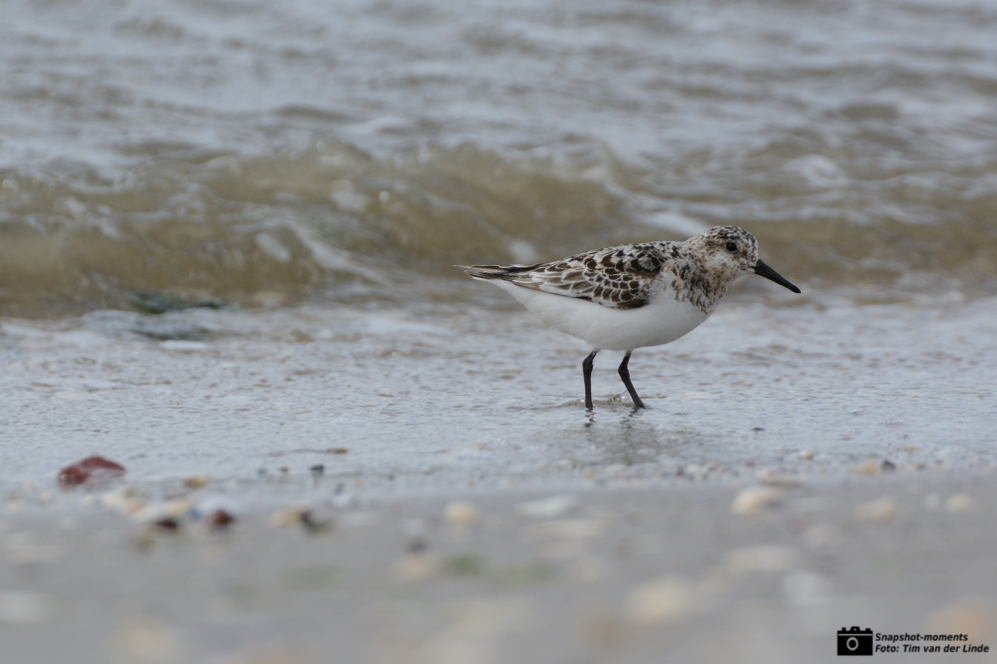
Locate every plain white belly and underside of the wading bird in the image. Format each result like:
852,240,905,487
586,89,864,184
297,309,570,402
489,280,712,350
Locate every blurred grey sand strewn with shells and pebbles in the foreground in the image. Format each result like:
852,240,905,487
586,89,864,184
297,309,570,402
0,471,997,664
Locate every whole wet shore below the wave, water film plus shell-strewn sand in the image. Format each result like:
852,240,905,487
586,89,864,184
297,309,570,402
0,291,997,664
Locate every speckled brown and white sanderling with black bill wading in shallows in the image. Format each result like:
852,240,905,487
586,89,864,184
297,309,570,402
457,226,800,410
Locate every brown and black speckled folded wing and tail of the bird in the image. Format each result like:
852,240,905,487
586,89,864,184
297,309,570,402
462,242,667,309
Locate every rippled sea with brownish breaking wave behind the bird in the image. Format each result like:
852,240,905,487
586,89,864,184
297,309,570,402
0,0,997,316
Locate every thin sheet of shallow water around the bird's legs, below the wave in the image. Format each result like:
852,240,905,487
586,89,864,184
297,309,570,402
0,296,997,488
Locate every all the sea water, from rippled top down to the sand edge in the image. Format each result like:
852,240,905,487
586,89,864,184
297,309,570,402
0,0,997,488
